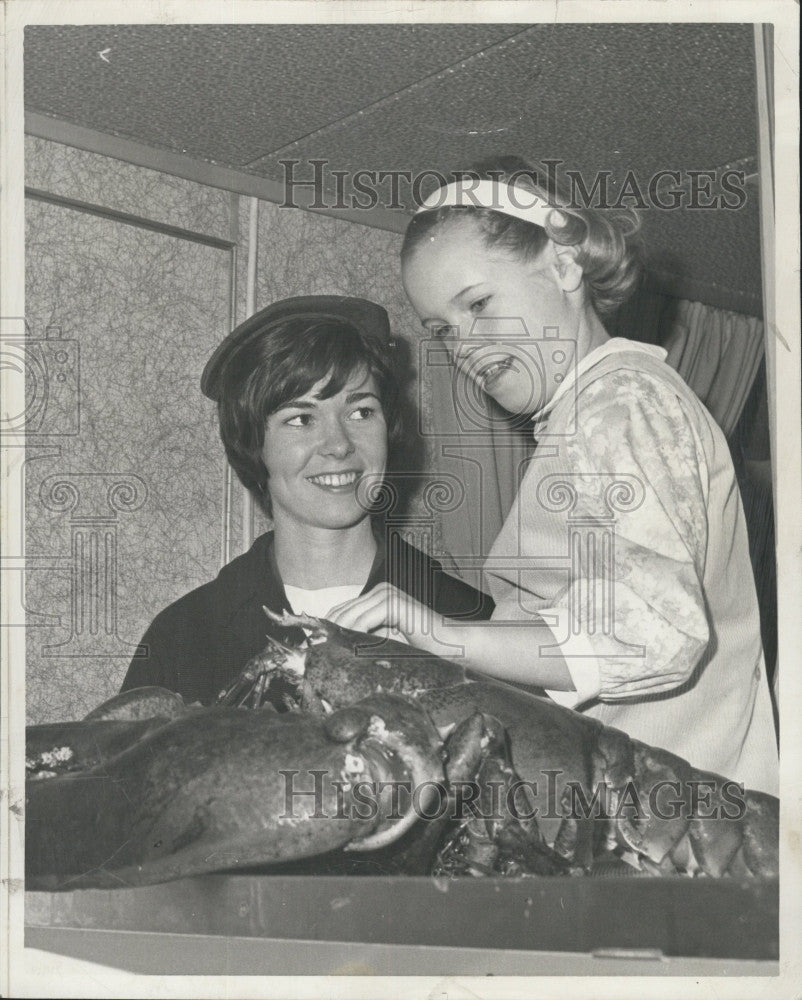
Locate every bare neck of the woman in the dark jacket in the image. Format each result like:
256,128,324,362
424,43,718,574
273,515,376,590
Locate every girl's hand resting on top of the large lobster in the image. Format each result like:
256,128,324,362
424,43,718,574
326,583,441,653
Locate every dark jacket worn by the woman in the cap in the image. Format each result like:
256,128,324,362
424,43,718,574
122,532,493,705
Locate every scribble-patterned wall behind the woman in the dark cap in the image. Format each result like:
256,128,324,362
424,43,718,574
24,138,432,723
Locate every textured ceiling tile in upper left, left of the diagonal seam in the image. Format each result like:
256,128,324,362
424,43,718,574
25,25,521,166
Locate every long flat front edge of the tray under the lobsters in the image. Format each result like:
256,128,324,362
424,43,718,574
26,875,779,974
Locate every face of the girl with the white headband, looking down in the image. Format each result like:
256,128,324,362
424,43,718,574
402,219,584,414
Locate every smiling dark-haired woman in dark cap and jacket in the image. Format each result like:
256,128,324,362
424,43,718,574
123,296,493,704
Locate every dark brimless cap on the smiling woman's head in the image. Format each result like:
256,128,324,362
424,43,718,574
201,295,392,402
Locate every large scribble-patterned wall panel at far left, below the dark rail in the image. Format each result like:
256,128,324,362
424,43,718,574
26,191,229,722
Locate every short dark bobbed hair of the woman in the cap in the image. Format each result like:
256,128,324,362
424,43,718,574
217,317,403,516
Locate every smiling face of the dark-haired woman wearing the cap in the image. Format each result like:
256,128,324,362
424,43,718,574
262,371,387,529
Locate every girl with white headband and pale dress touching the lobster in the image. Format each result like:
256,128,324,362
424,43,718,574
330,158,778,794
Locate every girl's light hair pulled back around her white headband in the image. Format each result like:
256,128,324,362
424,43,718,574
401,156,642,316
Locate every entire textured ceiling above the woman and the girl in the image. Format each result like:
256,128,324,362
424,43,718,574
25,24,760,312
